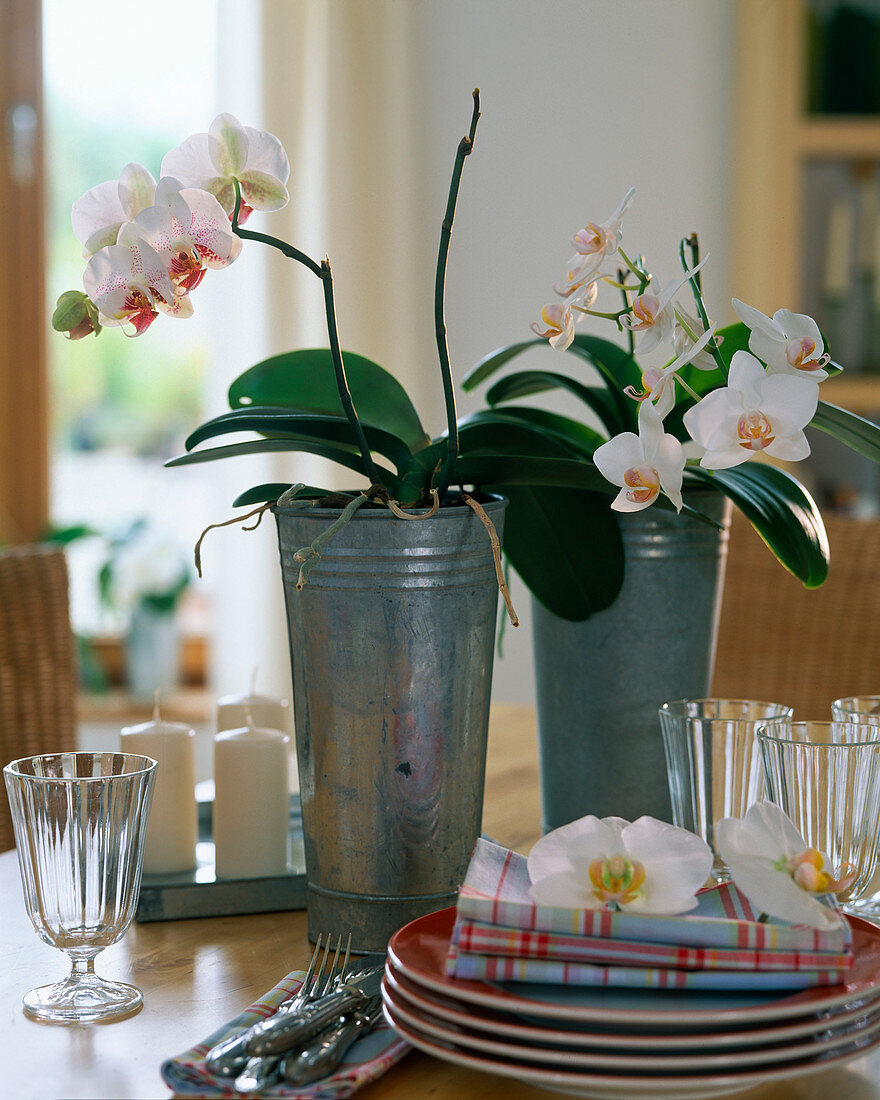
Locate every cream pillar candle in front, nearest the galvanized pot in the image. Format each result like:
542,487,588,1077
213,724,290,879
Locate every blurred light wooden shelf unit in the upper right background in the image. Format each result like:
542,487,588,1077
730,0,880,510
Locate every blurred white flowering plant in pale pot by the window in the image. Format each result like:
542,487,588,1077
98,519,191,702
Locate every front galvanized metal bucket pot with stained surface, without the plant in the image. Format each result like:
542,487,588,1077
275,499,507,952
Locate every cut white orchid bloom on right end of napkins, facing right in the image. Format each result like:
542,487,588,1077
715,801,856,928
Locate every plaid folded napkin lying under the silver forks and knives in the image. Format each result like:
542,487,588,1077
162,970,409,1100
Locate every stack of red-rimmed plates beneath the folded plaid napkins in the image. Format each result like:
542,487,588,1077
383,909,880,1100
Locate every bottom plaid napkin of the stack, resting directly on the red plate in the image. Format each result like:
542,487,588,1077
447,944,845,990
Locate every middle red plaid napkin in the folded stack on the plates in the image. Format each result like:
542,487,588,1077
452,921,853,980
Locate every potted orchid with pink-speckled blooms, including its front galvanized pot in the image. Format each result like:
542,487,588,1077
54,92,624,949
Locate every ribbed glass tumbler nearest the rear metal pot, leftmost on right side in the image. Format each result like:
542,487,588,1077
660,699,792,882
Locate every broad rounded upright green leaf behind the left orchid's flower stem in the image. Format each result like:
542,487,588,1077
229,348,430,451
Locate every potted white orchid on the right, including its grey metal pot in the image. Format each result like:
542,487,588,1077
461,191,880,828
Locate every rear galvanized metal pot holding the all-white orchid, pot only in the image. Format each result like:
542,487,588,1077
532,492,730,832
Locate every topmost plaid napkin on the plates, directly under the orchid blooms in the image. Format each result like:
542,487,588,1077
458,838,851,960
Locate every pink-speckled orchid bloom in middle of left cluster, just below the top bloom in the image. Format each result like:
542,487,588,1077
119,176,242,296
